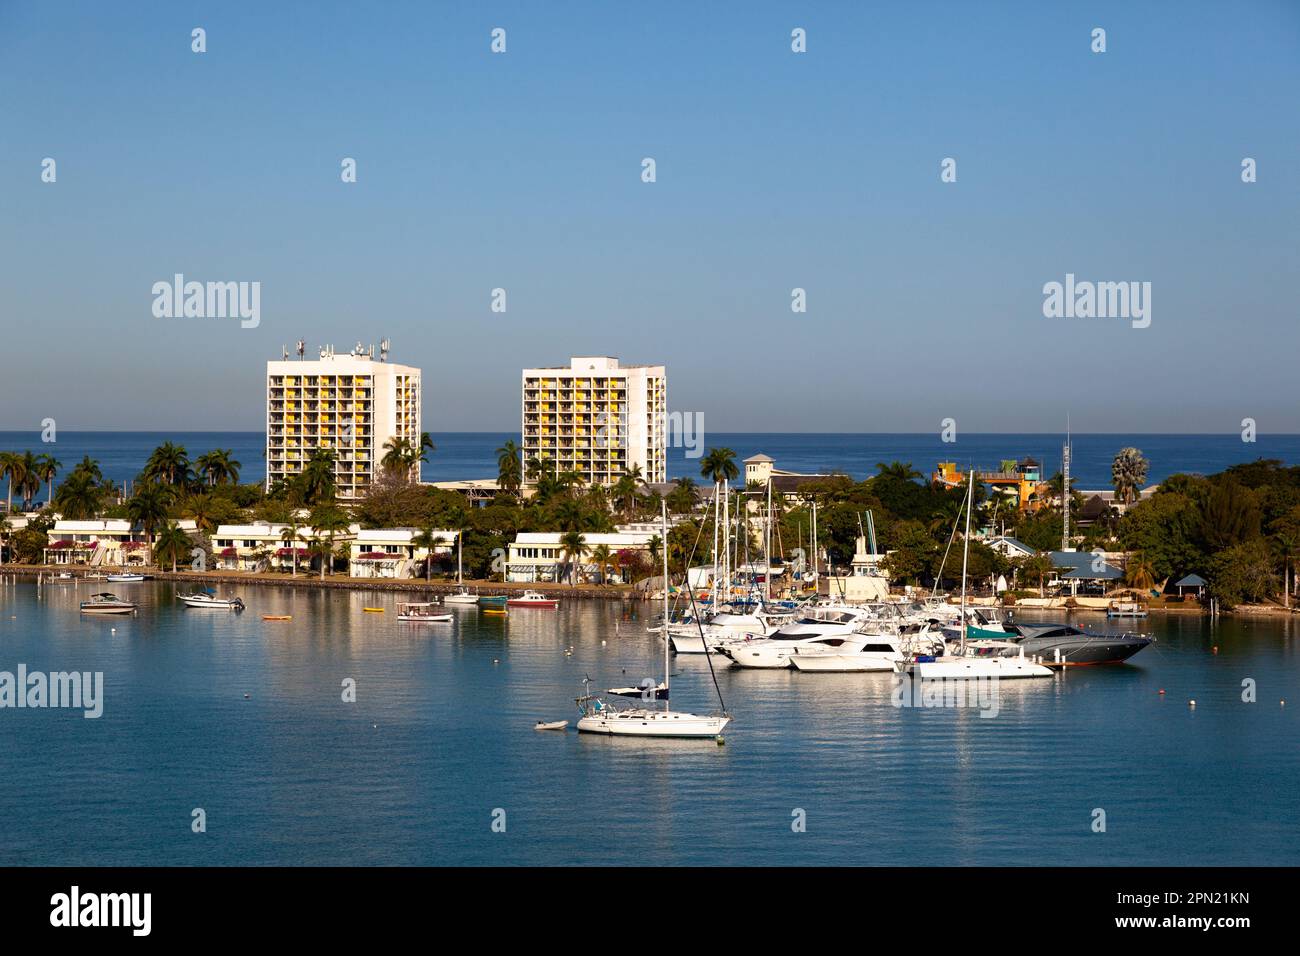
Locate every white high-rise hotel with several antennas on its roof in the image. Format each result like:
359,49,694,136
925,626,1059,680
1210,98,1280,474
267,342,420,499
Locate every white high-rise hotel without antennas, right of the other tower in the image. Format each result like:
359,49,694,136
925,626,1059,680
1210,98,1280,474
523,356,668,485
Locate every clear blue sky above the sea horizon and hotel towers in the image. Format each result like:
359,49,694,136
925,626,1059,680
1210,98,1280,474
0,0,1300,432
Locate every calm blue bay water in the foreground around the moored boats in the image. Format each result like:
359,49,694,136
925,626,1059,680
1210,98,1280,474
0,579,1300,865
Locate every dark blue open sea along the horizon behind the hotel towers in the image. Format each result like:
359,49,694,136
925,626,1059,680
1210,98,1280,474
0,431,1300,490
